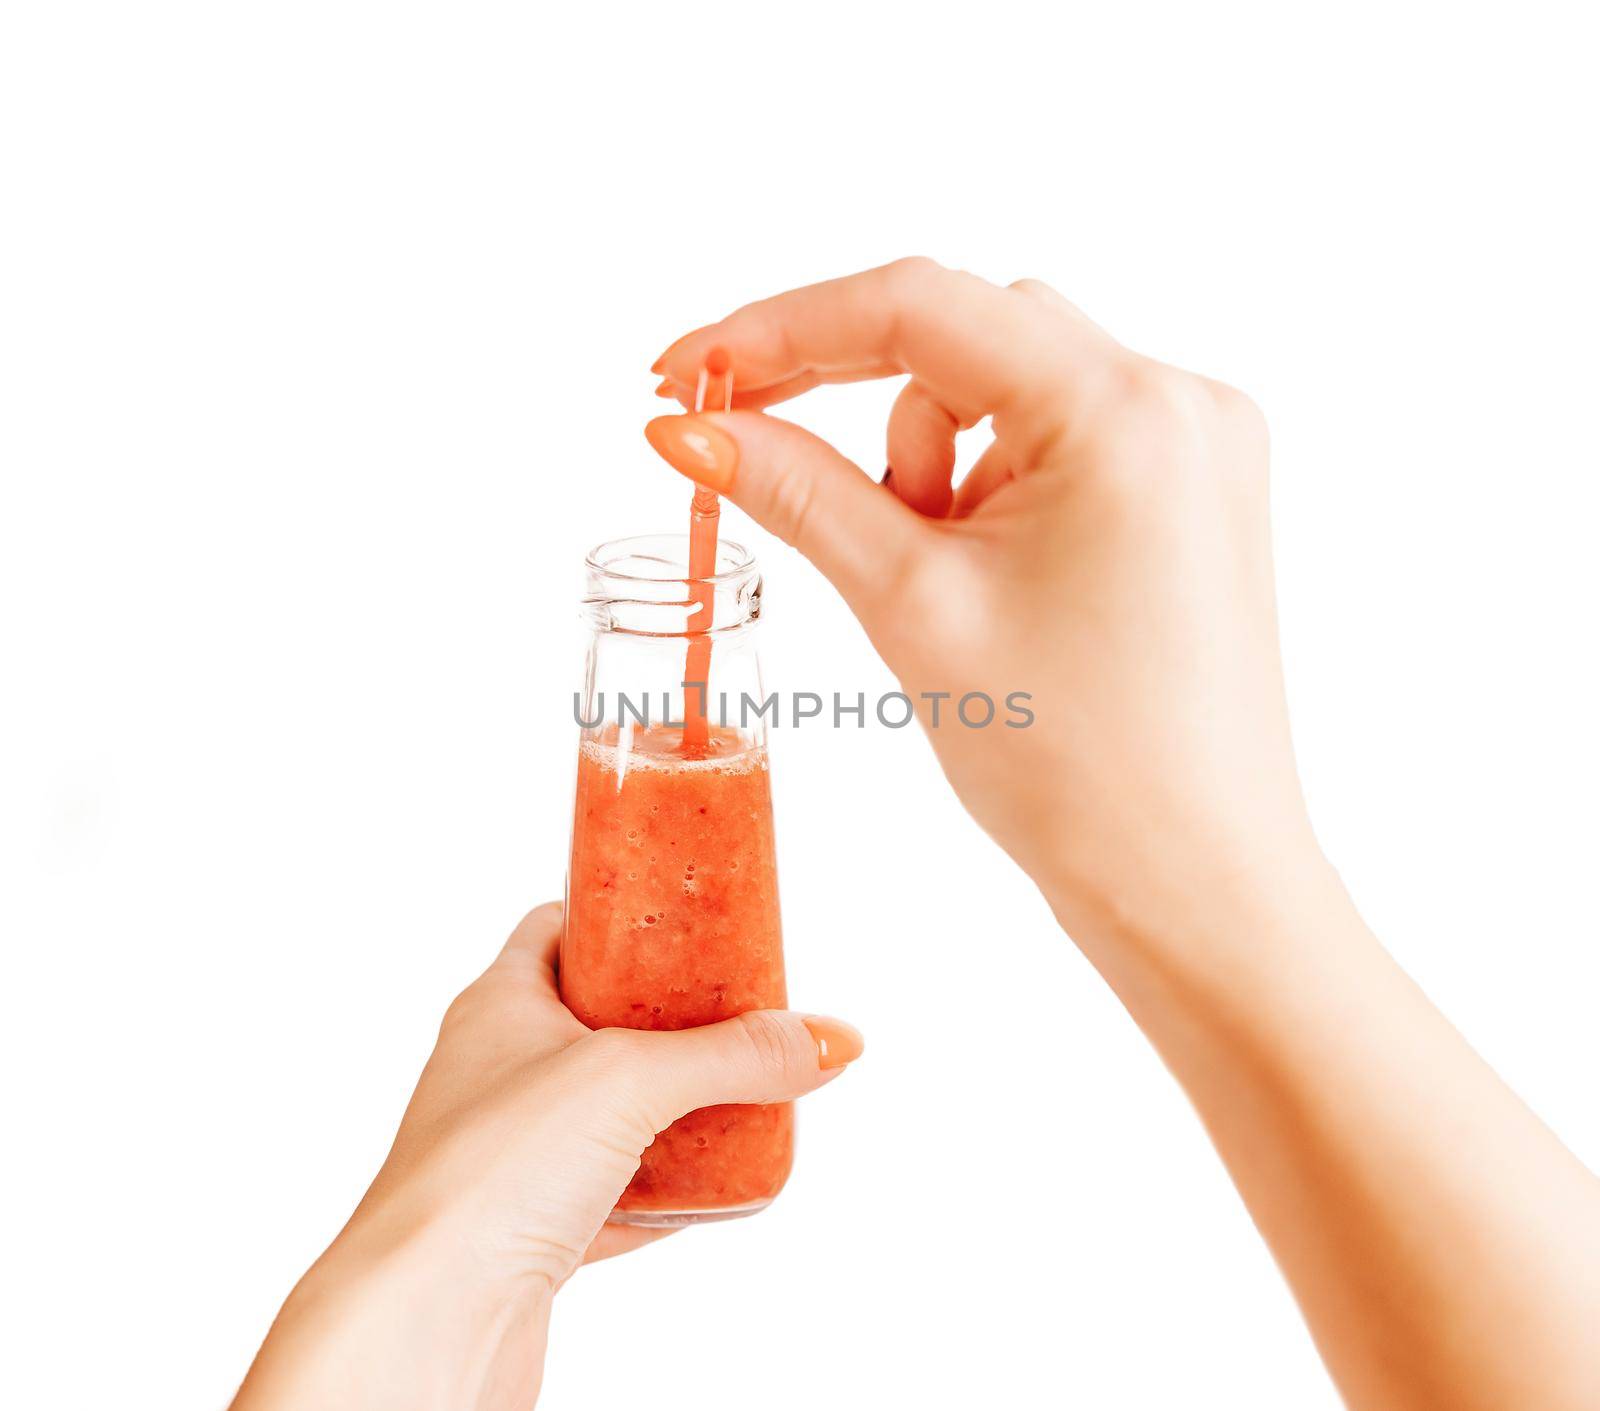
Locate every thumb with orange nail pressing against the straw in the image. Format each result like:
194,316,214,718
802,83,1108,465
645,411,930,627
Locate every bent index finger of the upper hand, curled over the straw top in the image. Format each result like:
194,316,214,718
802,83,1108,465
656,259,1115,426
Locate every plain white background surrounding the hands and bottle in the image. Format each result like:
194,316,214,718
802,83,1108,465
0,0,1600,1411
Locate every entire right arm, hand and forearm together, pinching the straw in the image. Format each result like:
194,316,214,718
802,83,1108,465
648,261,1600,1411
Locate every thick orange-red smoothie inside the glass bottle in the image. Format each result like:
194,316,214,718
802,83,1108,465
562,726,794,1222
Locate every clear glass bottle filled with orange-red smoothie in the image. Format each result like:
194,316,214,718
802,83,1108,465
560,534,794,1225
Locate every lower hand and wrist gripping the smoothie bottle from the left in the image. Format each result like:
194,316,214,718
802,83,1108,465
234,904,861,1411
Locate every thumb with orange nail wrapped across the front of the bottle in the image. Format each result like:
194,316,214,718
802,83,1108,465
617,1009,862,1131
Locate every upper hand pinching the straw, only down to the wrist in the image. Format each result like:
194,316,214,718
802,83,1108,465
648,259,1317,941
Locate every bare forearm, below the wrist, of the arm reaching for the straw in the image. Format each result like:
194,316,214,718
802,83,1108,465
1058,857,1600,1408
